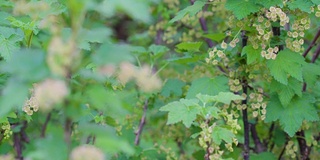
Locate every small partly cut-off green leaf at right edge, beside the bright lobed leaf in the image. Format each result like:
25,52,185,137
302,63,320,87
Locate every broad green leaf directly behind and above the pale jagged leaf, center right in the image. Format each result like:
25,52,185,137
186,76,229,98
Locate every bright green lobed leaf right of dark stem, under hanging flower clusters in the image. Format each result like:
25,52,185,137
267,49,305,85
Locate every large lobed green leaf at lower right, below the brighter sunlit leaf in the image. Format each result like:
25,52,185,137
265,94,319,137
